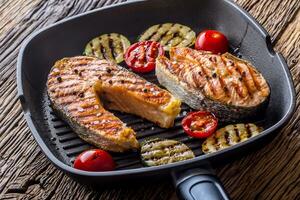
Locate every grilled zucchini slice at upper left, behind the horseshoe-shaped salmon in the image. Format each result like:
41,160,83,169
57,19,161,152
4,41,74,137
84,33,130,63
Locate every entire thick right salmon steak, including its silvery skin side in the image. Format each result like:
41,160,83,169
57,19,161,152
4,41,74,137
156,47,270,121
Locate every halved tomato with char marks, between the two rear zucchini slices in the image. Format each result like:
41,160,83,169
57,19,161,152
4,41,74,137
125,41,164,73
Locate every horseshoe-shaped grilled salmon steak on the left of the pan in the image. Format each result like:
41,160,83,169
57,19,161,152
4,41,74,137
47,56,181,152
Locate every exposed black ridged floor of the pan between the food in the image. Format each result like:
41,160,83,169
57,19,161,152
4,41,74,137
43,73,202,169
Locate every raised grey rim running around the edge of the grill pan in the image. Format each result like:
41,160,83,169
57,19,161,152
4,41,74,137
17,0,296,177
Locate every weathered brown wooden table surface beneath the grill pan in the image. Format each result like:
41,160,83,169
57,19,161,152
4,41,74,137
0,0,300,200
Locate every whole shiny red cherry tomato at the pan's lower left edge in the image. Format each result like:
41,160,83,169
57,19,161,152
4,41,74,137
74,149,116,171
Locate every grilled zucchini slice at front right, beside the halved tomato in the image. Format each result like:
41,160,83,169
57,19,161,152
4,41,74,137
202,123,263,153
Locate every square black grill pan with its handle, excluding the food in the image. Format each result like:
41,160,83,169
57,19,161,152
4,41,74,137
17,0,295,199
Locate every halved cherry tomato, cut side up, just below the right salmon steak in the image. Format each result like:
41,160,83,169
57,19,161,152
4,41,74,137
181,111,218,138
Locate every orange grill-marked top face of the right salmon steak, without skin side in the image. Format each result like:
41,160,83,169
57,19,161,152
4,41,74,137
170,48,270,107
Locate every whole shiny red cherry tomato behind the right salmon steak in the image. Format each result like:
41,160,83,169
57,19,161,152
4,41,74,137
195,30,228,54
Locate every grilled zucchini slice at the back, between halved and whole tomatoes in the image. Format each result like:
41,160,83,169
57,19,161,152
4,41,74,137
139,23,196,51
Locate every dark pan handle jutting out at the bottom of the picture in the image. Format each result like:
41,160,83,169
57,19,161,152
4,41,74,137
173,168,230,200
